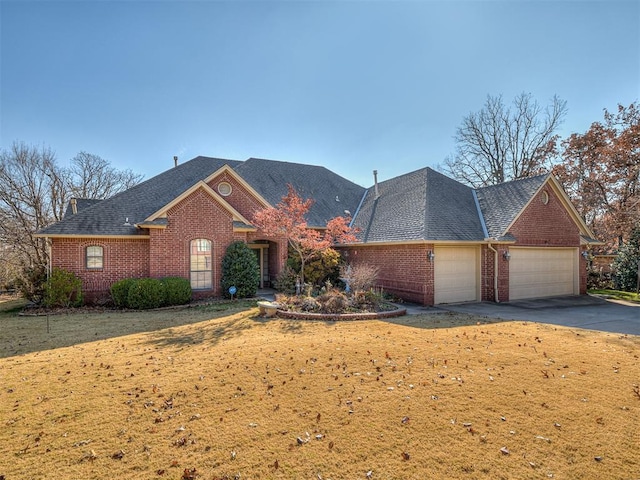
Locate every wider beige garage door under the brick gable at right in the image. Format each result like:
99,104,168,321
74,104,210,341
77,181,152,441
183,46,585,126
509,247,578,300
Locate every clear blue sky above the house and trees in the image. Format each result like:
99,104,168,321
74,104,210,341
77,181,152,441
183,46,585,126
0,0,640,186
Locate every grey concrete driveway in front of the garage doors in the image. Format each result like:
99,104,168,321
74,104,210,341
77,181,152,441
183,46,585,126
438,295,640,335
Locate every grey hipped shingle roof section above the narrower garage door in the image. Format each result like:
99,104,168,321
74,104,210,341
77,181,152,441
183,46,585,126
353,168,484,242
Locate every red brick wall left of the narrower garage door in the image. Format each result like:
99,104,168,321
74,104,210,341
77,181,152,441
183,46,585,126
340,244,434,305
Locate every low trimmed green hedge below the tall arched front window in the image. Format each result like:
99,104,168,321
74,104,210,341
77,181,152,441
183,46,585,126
110,277,191,310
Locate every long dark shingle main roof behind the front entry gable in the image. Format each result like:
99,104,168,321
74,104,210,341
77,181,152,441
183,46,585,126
39,156,365,235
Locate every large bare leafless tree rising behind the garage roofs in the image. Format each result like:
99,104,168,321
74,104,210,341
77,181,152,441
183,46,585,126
444,93,567,187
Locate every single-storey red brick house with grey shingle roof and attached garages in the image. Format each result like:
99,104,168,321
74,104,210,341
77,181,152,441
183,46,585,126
37,157,595,305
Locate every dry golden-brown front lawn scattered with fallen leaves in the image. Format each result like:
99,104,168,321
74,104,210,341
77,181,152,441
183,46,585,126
0,302,640,480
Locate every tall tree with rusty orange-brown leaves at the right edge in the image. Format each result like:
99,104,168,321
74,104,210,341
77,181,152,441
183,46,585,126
554,102,640,250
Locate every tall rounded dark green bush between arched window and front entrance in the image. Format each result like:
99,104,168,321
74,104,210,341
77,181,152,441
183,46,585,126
220,241,260,298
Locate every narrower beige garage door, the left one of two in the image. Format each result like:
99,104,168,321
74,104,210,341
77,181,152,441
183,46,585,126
433,247,478,303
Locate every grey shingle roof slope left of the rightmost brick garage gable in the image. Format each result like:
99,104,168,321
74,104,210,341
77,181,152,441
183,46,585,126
476,174,549,238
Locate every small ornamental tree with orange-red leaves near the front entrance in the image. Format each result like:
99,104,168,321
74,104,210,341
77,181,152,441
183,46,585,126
252,184,356,284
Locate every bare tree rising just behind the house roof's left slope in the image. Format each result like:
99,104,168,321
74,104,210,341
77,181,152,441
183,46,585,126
66,152,143,198
